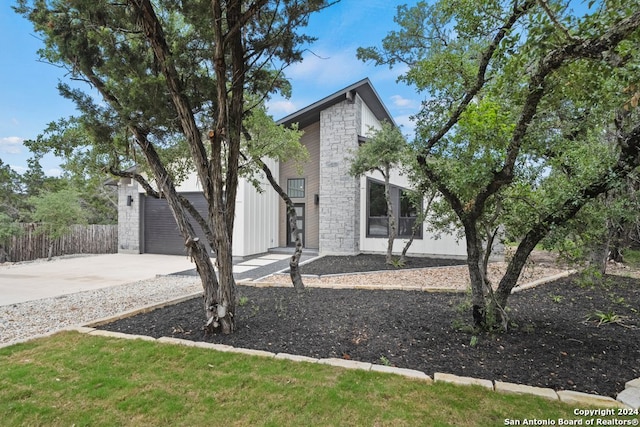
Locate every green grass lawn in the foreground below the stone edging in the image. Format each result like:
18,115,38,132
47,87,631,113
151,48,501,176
0,332,616,426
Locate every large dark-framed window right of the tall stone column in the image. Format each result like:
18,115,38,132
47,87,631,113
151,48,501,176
367,180,422,239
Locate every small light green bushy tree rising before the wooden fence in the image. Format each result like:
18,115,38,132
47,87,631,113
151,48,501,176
29,188,87,239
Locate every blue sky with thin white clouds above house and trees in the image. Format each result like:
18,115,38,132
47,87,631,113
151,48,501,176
0,0,421,175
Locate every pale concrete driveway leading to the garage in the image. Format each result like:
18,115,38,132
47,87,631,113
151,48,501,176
0,254,195,306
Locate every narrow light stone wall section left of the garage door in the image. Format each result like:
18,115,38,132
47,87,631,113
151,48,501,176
118,179,142,254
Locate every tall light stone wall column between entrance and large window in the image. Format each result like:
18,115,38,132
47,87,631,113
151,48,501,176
319,96,362,254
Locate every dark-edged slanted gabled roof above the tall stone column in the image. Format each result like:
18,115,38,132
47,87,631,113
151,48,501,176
277,78,395,129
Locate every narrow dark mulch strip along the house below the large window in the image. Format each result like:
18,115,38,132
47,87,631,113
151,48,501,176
300,254,467,276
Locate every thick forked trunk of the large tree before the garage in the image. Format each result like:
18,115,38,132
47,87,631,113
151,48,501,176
130,0,241,334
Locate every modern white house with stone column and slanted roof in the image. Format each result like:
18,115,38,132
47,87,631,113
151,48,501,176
118,79,466,257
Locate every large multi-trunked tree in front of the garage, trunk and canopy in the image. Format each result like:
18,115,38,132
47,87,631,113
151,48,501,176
17,0,328,333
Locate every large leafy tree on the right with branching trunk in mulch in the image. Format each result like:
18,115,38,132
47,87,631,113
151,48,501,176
358,0,640,326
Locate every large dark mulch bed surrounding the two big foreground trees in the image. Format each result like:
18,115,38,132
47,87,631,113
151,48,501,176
102,254,640,396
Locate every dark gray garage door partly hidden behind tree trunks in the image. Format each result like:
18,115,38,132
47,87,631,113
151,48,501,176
142,193,211,255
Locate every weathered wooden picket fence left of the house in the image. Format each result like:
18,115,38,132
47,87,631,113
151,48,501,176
0,224,118,262
